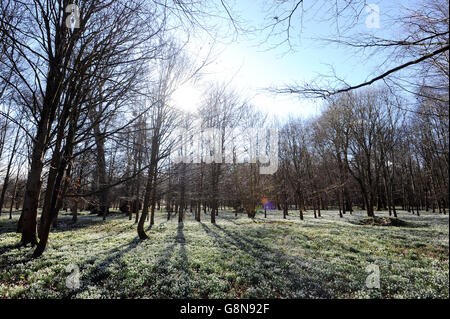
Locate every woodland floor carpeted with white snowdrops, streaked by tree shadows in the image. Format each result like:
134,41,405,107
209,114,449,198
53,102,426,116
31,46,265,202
0,211,449,298
